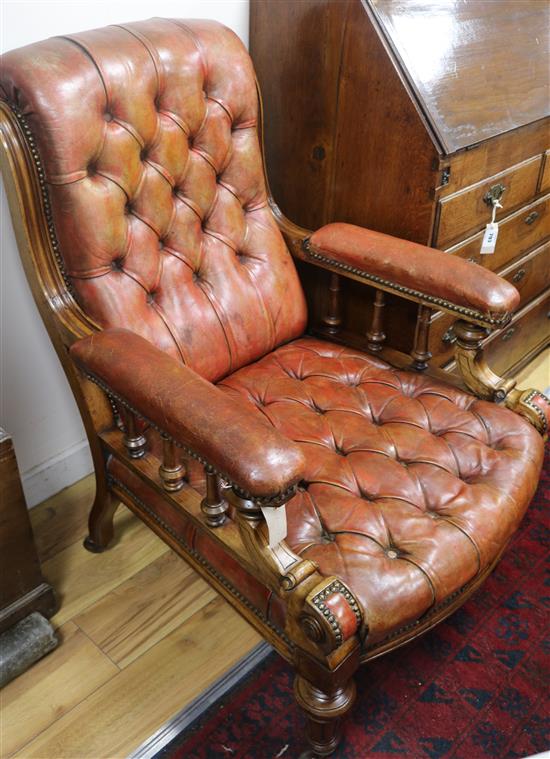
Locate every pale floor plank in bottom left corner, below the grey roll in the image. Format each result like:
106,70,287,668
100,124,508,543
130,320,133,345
0,622,119,759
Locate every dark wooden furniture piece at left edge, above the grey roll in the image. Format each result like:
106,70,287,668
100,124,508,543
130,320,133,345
0,428,57,633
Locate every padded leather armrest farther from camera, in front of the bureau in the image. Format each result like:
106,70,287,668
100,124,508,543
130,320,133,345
306,224,519,325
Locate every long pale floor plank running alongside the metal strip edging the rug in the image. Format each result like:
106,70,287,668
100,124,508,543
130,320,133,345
17,596,260,759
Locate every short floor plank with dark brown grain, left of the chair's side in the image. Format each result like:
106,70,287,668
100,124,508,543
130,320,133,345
74,552,216,667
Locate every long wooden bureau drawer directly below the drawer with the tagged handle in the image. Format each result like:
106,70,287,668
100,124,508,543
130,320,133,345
447,195,550,271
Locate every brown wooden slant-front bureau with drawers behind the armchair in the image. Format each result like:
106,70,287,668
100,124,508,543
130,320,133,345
250,0,550,374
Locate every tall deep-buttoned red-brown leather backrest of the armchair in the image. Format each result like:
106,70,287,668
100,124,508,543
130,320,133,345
1,19,306,380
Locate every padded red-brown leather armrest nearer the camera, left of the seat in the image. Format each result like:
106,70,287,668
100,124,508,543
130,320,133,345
70,329,305,505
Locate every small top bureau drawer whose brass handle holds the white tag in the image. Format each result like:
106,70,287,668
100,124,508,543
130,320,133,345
436,156,542,248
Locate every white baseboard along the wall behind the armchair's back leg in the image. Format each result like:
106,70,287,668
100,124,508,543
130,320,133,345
21,440,93,509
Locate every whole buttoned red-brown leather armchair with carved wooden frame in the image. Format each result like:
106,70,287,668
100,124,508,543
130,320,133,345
0,19,550,755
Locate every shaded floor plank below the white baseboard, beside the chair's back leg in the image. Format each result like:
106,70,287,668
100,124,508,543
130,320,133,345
30,474,95,562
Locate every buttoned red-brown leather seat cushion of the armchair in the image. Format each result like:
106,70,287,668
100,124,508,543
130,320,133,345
219,338,543,644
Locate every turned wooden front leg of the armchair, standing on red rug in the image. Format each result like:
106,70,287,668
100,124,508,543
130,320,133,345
294,675,355,756
